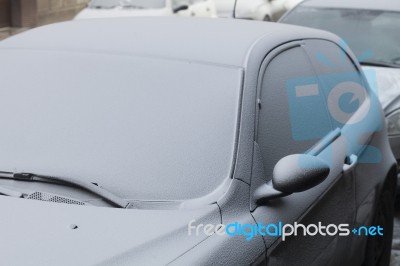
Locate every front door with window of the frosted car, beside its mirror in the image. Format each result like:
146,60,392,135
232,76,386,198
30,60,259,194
252,40,374,265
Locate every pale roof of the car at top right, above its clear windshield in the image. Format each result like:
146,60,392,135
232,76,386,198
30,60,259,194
300,0,400,12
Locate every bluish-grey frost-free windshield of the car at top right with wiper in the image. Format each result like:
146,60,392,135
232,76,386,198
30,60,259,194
281,6,400,67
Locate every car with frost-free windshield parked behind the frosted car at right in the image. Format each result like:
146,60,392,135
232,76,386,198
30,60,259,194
280,0,400,192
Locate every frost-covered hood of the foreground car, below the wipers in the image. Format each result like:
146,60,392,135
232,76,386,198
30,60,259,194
0,196,221,265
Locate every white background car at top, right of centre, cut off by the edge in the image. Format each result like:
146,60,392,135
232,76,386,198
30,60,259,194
215,0,301,21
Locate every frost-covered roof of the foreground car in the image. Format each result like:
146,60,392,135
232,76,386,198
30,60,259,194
0,17,336,67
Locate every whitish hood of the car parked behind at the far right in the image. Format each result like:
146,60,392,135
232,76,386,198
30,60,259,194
363,67,400,114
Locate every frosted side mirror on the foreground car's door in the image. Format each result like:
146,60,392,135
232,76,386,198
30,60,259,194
254,154,330,203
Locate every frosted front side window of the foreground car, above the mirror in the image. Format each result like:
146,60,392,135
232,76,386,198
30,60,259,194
256,45,333,180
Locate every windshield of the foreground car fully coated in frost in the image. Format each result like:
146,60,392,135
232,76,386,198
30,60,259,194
0,51,241,200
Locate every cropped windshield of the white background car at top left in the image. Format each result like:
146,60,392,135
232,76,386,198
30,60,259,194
89,0,166,9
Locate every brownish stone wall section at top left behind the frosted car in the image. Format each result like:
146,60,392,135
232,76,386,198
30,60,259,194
37,0,89,25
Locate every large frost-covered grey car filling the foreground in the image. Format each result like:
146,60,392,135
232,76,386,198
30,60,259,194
0,17,397,265
